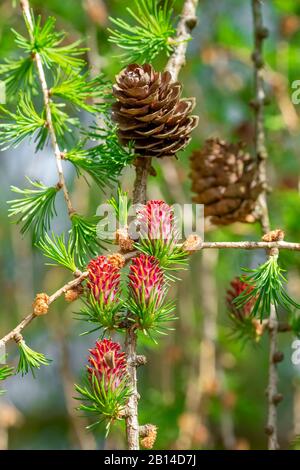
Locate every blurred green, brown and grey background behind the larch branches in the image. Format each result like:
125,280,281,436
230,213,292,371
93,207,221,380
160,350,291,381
0,0,300,449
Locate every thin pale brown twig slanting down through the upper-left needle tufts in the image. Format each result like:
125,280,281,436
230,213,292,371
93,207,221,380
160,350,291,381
20,0,75,215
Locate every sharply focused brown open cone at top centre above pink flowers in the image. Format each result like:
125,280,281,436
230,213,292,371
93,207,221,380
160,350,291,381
112,64,198,157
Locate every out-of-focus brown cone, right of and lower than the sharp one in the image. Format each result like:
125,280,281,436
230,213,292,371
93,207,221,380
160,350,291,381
190,139,263,225
